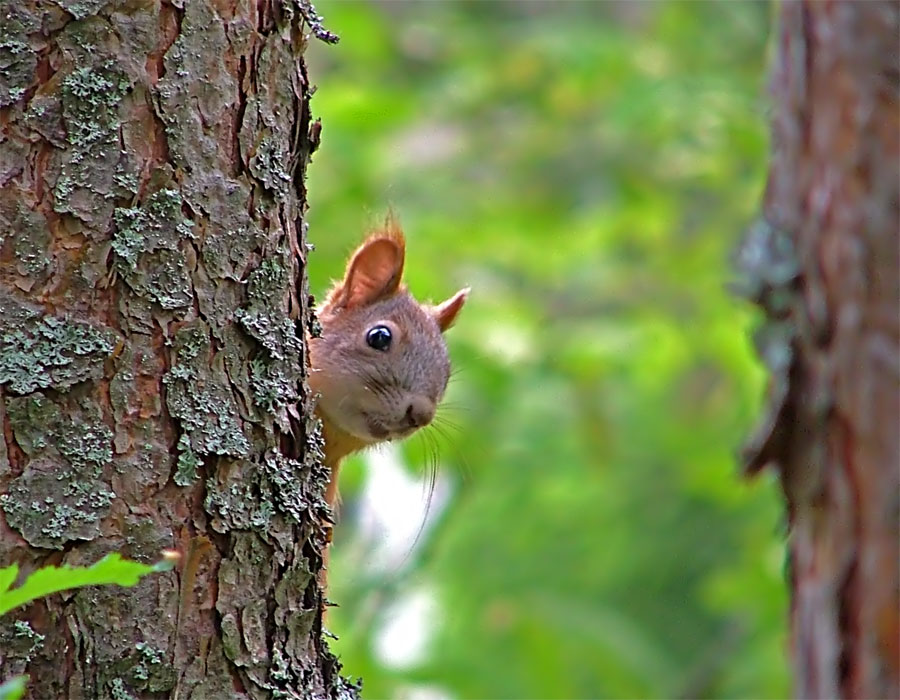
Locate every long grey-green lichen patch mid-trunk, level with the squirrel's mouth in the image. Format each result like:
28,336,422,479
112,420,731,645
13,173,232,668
163,321,250,482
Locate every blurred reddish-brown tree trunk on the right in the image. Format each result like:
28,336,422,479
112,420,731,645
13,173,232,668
742,0,900,698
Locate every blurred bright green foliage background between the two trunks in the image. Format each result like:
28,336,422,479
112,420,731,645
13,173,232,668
308,0,789,700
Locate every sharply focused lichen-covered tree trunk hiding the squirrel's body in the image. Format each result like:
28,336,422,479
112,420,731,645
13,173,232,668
0,0,355,699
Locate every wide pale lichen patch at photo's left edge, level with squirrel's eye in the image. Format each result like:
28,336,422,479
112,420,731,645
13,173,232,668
0,292,117,394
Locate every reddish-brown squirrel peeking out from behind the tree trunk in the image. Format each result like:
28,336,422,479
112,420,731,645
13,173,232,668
309,216,469,508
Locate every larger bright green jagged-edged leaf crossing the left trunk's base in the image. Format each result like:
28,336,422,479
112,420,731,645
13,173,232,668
0,552,158,615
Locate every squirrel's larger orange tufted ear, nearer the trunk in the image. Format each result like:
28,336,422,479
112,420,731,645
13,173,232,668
328,231,405,308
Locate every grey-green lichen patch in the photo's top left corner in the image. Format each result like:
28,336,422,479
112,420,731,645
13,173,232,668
0,0,41,107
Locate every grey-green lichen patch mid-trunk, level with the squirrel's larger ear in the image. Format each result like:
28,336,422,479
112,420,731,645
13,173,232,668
112,188,194,309
